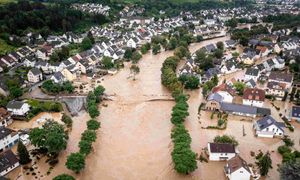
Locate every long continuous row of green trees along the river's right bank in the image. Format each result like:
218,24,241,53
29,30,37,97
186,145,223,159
161,39,197,174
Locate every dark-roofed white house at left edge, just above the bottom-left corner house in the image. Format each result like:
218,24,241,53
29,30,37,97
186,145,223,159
0,126,19,152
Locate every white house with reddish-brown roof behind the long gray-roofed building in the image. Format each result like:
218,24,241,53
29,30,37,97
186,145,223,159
243,88,265,107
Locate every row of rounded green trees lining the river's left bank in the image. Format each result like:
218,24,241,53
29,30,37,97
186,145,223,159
66,86,105,173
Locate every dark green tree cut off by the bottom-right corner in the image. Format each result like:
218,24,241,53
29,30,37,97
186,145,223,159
278,158,300,180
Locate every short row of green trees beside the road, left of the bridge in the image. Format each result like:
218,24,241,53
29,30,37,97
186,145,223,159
42,80,74,94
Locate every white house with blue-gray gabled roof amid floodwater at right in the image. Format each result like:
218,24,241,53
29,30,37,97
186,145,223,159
253,116,285,138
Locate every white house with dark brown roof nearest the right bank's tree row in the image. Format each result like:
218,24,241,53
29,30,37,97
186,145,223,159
207,143,237,161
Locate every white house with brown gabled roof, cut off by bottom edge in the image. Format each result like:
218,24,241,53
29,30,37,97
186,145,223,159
224,155,252,180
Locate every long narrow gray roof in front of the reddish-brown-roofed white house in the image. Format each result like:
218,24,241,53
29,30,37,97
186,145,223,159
221,103,257,115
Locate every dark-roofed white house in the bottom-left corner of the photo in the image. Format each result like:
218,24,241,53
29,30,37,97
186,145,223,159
0,150,20,177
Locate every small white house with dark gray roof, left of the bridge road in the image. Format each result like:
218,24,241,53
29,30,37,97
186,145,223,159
6,101,30,116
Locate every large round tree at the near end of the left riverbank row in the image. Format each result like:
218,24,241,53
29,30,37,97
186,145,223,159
66,153,85,173
